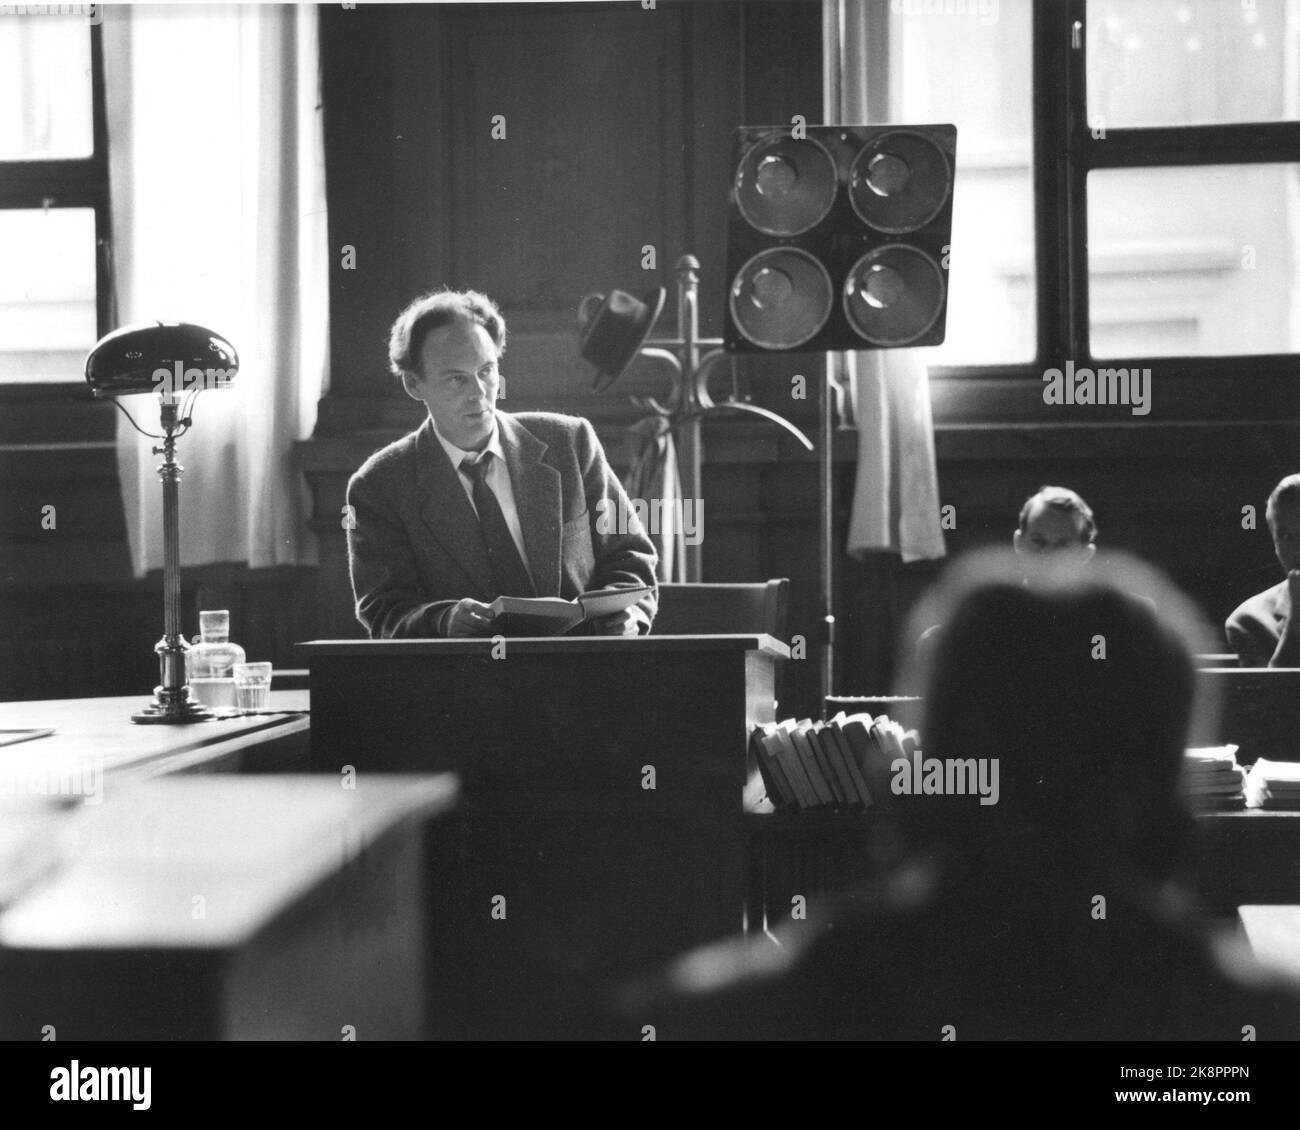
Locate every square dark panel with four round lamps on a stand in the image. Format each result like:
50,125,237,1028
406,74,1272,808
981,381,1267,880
724,125,957,352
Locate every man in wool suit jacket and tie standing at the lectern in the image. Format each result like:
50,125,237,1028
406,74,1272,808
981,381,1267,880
347,291,658,638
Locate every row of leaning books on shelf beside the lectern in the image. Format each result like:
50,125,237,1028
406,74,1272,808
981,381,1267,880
750,711,917,810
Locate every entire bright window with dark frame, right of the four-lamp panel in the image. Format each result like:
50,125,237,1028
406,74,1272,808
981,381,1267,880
876,0,1300,374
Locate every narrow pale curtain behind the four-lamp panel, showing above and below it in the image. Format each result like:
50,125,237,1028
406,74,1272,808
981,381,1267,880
823,0,945,562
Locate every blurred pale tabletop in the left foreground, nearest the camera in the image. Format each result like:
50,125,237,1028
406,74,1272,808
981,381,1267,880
0,774,458,949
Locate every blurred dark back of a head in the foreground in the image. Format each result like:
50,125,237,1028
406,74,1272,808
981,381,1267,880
896,544,1213,882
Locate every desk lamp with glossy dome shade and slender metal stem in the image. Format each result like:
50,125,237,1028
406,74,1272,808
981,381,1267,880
86,322,239,723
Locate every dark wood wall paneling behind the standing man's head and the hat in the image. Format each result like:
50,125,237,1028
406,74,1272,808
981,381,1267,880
321,4,717,405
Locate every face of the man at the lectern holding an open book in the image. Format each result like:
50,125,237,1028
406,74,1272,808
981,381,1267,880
407,321,501,451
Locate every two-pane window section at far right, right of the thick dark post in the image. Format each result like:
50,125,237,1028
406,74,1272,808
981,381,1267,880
1071,0,1300,359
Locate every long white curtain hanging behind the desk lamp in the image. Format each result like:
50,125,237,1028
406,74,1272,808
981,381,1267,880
104,4,329,575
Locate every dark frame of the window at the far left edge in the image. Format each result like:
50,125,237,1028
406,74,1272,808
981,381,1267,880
0,23,116,402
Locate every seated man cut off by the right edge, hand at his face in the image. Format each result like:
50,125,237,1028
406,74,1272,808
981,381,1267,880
1223,475,1300,667
